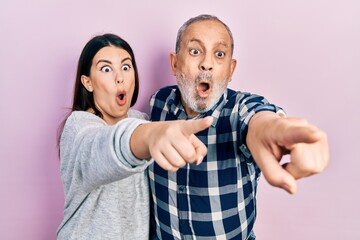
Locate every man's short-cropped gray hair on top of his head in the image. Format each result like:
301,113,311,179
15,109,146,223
175,14,234,54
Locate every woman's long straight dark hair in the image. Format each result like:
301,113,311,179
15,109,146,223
58,33,139,146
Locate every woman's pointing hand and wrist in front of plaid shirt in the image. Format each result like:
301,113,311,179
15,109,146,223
131,117,213,172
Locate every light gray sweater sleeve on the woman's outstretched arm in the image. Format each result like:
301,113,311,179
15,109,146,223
60,112,151,192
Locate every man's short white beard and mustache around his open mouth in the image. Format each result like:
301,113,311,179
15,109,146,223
176,73,228,113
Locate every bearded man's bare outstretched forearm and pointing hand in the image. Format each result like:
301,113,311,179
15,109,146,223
246,111,329,194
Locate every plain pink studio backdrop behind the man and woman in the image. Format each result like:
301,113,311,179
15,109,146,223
0,0,360,240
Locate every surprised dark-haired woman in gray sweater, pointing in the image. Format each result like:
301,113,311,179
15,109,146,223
57,34,212,240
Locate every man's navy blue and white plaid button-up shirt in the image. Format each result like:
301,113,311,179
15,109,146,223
149,86,282,240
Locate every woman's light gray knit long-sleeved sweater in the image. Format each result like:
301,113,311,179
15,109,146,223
57,110,152,240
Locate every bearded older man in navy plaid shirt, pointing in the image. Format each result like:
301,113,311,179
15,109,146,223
149,15,329,239
